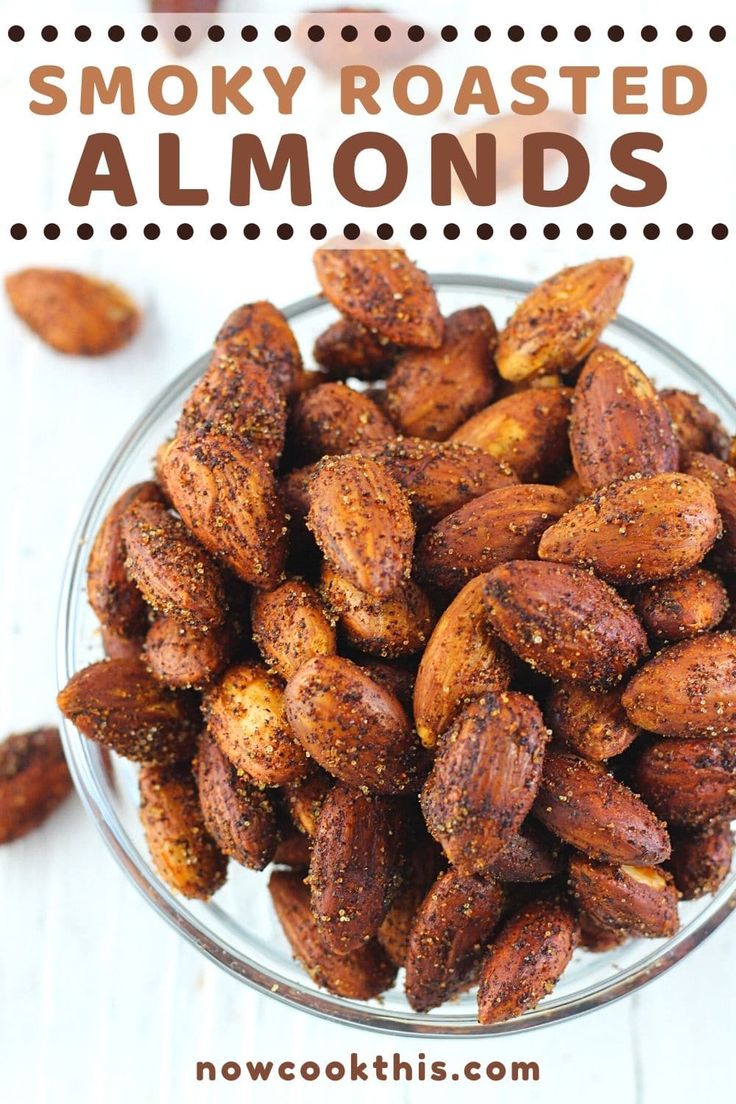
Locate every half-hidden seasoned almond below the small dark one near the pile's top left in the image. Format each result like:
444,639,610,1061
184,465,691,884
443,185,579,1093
291,383,396,460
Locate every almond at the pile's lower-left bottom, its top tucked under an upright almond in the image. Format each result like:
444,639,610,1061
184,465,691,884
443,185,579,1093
268,870,396,1000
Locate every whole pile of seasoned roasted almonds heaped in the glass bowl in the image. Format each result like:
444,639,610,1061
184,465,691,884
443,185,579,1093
58,248,736,1023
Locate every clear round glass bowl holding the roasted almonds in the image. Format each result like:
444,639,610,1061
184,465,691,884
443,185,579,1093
58,275,736,1038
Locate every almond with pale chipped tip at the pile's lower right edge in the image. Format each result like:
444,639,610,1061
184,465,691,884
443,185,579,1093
569,854,680,940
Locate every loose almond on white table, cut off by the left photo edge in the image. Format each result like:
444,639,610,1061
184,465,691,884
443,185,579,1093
0,728,73,843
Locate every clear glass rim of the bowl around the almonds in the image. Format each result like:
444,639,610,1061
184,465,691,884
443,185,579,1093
56,273,736,1039
